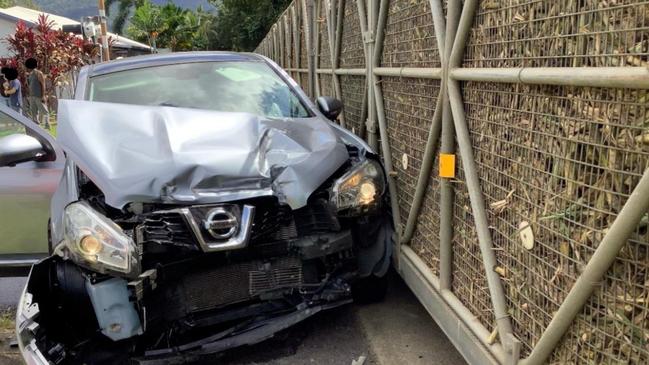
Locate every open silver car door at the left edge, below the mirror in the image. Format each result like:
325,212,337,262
0,105,65,269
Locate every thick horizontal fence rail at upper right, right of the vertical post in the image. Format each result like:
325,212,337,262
451,67,649,89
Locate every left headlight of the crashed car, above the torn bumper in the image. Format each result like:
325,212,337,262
63,202,140,276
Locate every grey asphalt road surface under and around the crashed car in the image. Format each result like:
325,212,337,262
0,273,465,365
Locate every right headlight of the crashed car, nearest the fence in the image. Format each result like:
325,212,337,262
332,160,385,215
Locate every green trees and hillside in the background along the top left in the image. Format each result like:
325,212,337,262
0,0,291,51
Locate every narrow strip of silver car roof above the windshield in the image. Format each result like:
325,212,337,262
88,52,264,77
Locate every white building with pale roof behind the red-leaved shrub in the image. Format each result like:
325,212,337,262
0,6,151,58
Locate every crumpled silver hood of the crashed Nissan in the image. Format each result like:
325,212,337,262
57,100,349,209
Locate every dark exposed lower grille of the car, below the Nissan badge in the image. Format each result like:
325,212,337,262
182,257,303,313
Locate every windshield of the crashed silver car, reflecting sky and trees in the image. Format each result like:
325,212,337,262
88,62,310,118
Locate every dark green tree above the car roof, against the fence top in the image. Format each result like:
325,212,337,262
210,0,291,51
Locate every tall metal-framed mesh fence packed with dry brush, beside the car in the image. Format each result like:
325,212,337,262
257,0,649,364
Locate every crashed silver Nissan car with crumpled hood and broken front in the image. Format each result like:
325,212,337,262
0,53,393,365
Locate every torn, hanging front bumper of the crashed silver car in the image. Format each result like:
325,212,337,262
16,218,391,365
